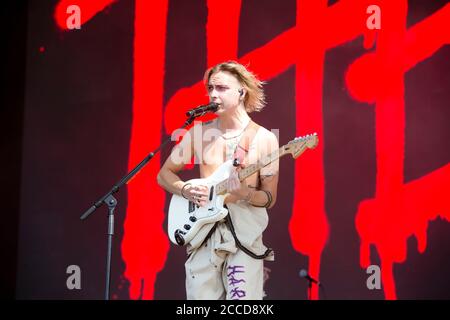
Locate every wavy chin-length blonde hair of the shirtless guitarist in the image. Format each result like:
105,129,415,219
204,61,266,113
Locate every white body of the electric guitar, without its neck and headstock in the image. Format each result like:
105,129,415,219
167,160,233,246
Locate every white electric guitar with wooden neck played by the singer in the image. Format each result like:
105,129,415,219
167,133,319,246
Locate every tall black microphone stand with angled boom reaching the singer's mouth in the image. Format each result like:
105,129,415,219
80,111,206,300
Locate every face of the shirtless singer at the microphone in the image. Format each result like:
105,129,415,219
208,71,241,115
